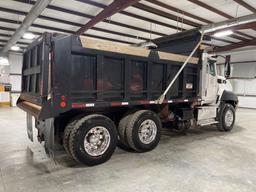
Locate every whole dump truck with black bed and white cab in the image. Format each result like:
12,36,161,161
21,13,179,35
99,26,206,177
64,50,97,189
17,31,238,166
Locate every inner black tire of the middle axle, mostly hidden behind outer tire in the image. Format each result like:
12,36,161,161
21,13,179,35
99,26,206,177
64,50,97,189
117,114,132,150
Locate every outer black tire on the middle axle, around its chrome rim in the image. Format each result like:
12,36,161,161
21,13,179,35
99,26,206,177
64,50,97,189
126,110,162,152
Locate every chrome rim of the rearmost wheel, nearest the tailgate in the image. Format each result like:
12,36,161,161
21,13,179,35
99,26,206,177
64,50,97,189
84,126,110,156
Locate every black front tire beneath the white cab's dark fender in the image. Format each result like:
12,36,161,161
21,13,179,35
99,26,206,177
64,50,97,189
217,103,236,131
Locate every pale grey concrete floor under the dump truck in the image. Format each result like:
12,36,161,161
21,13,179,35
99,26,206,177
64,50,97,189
0,108,256,192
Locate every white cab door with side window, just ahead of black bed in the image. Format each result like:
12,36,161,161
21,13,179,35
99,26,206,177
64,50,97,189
201,54,218,104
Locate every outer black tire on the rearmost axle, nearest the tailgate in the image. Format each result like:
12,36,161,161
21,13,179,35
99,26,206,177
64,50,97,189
69,114,117,166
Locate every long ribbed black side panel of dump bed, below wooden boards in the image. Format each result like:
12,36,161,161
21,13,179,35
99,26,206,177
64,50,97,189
54,36,199,111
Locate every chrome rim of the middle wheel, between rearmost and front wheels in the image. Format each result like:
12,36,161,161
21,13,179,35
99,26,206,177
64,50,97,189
139,119,157,144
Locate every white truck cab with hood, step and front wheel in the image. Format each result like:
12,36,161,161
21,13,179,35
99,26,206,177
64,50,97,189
197,53,238,131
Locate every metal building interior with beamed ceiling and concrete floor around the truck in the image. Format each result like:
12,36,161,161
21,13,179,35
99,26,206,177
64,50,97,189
0,0,256,192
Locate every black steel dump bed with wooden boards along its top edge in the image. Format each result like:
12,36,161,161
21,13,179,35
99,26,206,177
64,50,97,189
17,30,201,119
